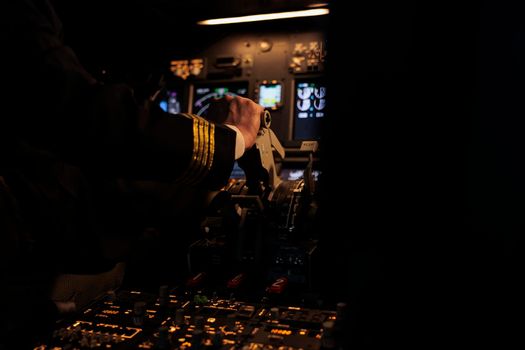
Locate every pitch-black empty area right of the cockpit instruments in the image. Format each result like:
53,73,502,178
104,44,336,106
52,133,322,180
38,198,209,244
324,1,525,346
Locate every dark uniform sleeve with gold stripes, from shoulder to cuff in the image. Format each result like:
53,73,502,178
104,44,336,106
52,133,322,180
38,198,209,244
2,0,236,189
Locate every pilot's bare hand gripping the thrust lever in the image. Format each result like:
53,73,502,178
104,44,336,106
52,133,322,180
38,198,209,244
224,95,264,149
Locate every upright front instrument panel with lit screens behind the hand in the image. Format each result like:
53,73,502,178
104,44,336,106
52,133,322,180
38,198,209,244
161,30,329,148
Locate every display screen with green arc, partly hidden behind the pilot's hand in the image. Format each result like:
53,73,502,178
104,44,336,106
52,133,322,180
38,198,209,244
191,81,248,117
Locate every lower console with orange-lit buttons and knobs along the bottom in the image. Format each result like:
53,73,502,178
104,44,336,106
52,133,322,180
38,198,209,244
34,286,343,350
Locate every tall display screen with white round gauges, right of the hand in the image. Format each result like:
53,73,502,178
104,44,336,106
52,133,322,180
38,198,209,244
294,78,326,140
